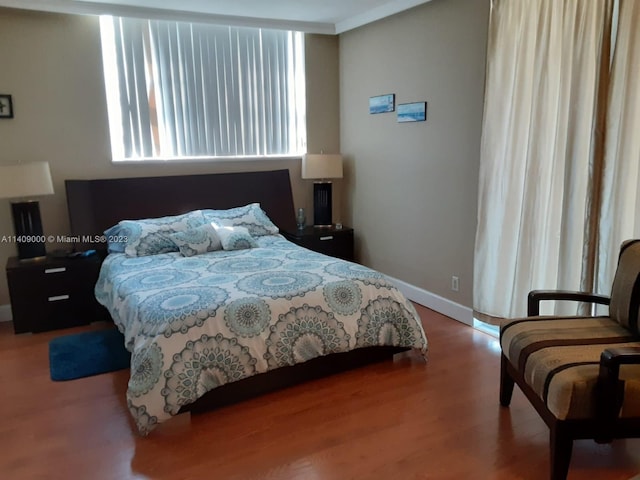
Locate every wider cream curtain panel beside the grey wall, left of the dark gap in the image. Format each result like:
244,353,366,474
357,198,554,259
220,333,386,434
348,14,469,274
474,0,616,323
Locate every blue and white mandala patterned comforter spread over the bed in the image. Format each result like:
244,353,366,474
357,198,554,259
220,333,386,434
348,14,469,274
95,235,427,434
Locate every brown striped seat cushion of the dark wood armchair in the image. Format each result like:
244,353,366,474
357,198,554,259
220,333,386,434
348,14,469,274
500,317,640,420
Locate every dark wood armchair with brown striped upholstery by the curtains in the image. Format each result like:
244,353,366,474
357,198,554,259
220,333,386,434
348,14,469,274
500,240,640,480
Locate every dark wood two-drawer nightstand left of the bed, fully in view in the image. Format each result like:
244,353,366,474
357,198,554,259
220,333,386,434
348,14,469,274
6,255,110,333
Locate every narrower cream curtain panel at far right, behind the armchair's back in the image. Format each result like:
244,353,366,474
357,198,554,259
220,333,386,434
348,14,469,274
597,0,640,294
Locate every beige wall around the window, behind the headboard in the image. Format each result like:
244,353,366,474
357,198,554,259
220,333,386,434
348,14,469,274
0,9,340,304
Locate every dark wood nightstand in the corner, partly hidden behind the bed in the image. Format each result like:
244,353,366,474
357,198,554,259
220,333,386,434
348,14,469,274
280,225,354,262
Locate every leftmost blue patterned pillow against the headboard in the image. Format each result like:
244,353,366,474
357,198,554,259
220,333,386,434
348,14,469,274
112,210,205,257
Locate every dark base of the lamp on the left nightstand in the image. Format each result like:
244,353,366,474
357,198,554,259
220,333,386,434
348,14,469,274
11,201,47,260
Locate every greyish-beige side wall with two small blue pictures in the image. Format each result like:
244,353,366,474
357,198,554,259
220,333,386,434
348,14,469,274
340,0,489,307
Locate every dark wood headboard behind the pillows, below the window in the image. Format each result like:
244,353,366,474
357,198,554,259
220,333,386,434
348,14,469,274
65,170,295,249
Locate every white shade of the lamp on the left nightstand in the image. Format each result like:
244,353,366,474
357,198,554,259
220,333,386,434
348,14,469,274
0,162,53,198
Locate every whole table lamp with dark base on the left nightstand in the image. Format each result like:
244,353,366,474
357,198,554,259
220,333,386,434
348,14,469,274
0,162,53,260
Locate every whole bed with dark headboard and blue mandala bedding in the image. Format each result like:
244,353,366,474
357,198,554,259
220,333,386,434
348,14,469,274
66,170,427,435
